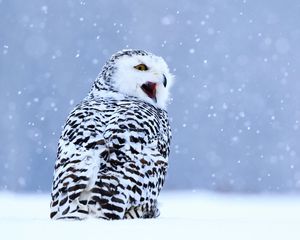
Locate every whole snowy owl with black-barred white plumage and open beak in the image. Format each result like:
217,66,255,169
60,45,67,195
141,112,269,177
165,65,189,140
50,50,173,219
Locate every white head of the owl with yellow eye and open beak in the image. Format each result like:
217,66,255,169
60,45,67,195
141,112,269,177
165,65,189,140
91,49,173,109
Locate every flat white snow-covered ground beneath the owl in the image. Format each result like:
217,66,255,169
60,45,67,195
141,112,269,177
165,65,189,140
0,192,300,240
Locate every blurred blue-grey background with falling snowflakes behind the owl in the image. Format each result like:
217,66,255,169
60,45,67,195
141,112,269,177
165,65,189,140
0,0,300,193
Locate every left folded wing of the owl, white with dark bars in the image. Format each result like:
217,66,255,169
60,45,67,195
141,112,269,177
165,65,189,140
50,102,106,218
